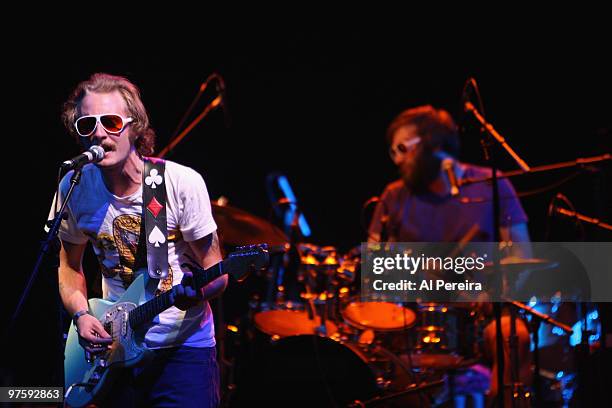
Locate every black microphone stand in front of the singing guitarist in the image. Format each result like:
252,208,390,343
6,165,82,385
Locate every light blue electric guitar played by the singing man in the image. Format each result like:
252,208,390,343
64,245,269,407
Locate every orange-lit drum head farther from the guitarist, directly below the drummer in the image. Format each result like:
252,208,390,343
342,302,416,331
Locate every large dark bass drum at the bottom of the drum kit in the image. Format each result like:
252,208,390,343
234,335,430,407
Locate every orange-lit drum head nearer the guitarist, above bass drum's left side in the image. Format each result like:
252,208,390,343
254,310,338,337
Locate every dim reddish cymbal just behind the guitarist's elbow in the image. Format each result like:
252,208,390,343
211,201,289,247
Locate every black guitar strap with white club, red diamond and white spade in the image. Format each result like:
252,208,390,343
136,157,168,294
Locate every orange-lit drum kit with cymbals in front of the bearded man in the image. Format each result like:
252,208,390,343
213,202,584,406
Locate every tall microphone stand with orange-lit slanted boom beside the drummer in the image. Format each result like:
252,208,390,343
464,97,530,408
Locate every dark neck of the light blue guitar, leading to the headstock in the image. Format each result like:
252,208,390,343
129,261,225,328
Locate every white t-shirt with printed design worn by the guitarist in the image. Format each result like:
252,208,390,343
50,161,217,348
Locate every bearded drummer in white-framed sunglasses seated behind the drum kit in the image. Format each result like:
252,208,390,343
368,105,532,402
